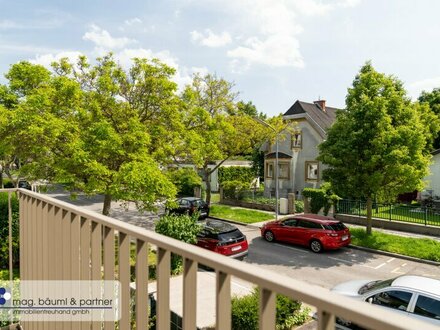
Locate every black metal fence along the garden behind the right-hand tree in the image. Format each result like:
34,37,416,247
335,200,440,226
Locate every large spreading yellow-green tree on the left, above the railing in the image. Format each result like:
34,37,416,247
2,54,179,214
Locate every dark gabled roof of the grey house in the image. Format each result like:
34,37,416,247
283,100,338,135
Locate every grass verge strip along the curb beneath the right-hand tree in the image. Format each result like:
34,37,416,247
350,228,440,261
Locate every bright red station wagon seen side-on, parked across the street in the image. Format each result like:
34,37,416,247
260,214,351,253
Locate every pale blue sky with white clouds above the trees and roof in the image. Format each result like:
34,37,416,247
0,0,440,116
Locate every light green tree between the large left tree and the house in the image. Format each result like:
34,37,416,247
182,74,267,203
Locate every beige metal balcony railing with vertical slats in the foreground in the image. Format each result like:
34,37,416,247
0,189,435,330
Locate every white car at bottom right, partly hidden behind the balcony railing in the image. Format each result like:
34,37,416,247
332,275,440,329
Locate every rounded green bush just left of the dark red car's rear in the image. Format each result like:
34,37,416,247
155,212,202,274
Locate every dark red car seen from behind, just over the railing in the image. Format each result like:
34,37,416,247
197,220,248,259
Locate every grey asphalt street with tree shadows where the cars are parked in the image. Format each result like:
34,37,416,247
49,192,440,289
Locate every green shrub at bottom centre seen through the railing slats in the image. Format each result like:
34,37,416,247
231,288,305,330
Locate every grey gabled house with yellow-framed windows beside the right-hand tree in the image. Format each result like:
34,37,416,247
263,100,337,198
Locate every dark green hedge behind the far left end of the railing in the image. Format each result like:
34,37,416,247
0,193,20,269
